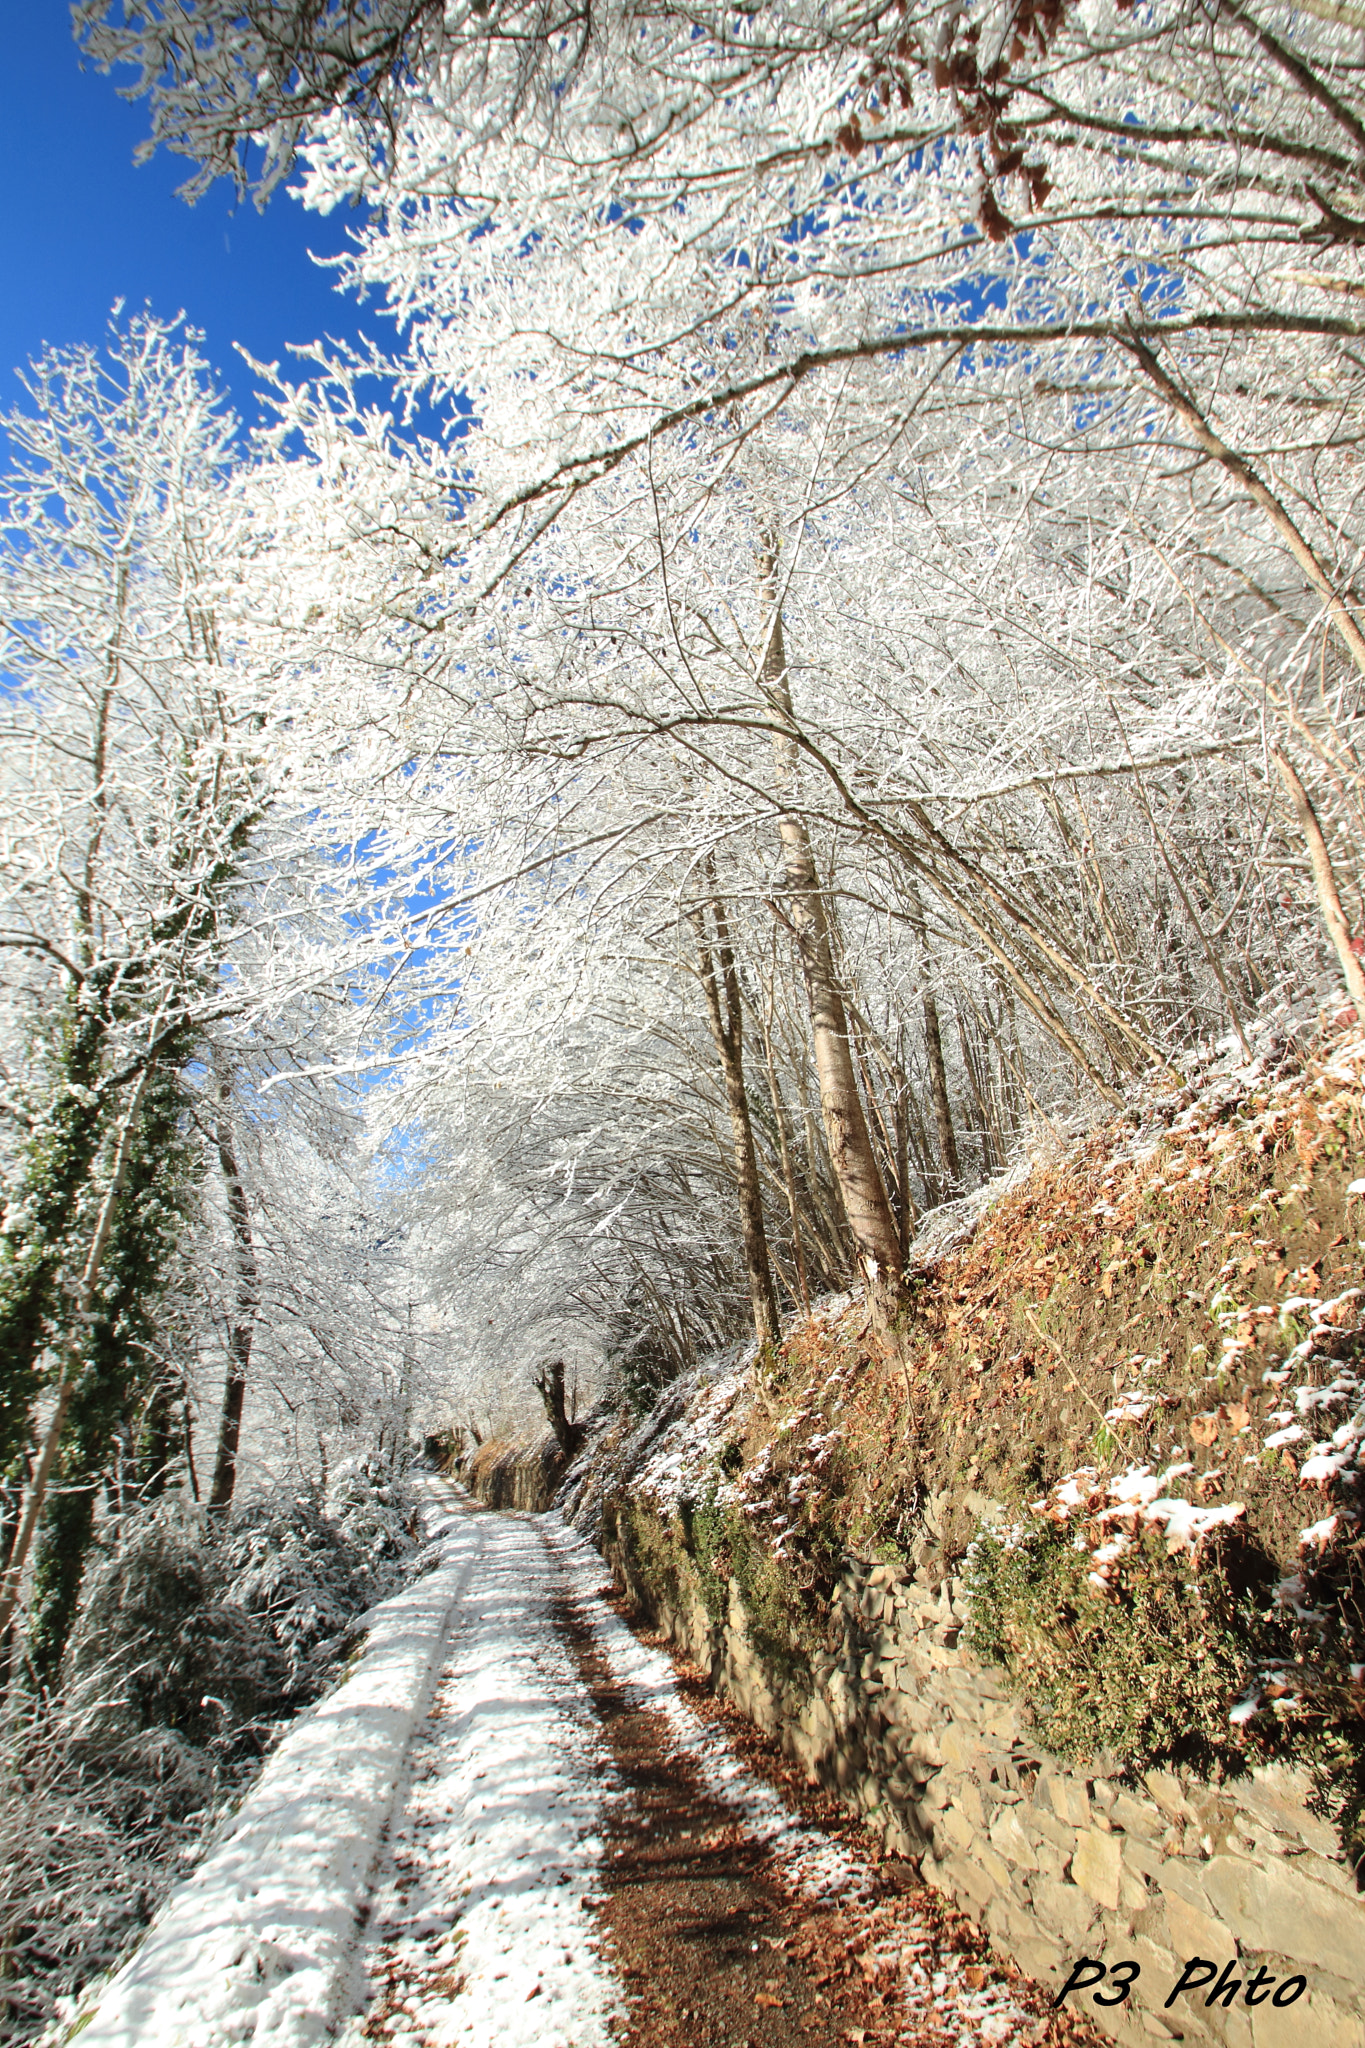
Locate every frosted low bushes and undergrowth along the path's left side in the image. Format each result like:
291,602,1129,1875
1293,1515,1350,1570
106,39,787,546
9,1460,415,2042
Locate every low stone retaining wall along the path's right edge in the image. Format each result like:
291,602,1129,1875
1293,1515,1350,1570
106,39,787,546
608,1548,1365,2048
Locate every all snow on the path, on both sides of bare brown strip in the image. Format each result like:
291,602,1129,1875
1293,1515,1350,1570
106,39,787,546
63,1481,1023,2048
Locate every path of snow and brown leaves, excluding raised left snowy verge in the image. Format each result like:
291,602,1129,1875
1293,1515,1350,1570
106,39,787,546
340,1503,1095,2048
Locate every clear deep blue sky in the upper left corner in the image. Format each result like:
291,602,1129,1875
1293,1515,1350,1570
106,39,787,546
0,0,384,418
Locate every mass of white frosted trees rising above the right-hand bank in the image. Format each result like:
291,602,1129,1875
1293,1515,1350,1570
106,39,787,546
72,0,1365,1392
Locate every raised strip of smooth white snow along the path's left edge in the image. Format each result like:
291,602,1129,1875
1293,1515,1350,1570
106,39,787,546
80,1490,477,2048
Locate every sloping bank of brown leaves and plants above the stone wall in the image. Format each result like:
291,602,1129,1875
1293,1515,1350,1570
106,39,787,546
606,1014,1365,1855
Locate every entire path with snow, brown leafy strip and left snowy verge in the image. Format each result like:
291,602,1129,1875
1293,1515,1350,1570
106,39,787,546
69,1481,1044,2048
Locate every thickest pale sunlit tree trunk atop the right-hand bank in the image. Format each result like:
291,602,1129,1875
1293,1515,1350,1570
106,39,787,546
761,551,902,1331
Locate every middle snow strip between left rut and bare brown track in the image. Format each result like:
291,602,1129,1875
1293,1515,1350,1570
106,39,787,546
342,1513,622,2048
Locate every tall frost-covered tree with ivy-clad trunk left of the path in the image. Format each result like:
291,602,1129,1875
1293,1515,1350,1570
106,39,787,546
0,315,446,1657
